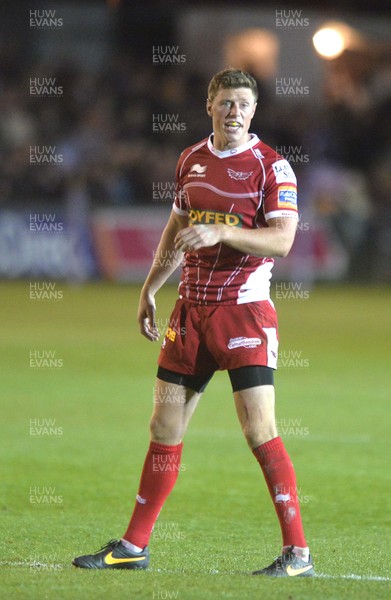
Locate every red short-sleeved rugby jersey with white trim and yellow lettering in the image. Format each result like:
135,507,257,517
173,134,298,304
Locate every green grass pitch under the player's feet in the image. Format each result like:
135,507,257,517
0,282,391,600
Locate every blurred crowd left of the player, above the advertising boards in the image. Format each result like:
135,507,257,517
0,47,209,206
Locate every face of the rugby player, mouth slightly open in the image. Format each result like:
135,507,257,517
206,88,257,150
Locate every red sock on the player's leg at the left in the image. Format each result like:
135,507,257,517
123,442,183,548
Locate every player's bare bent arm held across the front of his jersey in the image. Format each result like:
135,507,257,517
175,215,297,257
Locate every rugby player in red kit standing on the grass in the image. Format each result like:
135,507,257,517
73,68,314,577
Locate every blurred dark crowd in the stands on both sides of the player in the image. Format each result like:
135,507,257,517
0,44,391,279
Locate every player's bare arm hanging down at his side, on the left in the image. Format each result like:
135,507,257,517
137,211,188,342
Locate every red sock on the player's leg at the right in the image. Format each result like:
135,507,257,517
253,437,307,548
